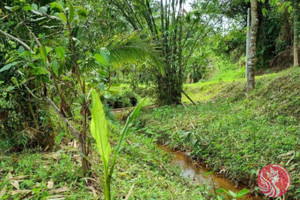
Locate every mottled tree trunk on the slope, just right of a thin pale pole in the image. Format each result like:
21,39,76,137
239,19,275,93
247,0,259,92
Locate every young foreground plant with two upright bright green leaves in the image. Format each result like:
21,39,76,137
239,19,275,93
90,90,144,200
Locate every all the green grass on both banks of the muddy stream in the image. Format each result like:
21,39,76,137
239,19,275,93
0,68,300,199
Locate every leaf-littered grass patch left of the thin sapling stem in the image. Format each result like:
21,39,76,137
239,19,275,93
0,151,93,199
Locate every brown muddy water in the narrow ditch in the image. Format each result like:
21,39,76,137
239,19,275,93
160,146,262,200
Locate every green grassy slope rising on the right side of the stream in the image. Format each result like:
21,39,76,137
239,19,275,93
140,68,300,199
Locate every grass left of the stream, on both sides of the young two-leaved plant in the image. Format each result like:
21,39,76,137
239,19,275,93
0,119,209,200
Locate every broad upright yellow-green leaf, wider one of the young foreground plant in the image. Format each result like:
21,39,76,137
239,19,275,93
91,90,111,172
